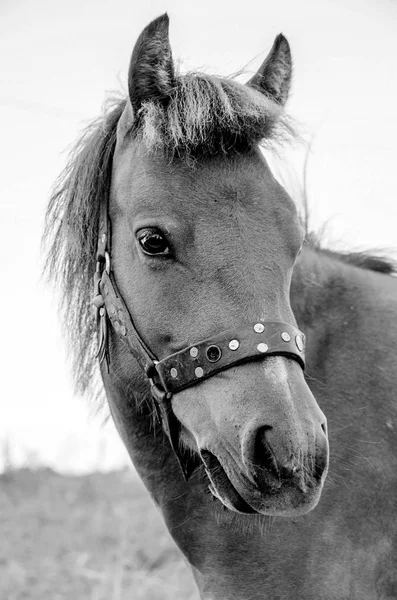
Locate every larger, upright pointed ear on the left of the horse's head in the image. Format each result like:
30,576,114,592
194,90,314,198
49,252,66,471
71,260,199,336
128,13,175,112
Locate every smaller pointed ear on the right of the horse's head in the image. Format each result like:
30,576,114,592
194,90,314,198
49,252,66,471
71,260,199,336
247,33,292,106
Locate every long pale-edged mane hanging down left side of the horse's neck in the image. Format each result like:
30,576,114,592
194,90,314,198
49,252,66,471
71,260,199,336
43,100,125,393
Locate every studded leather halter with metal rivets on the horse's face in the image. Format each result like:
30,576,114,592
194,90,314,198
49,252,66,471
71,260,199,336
92,199,305,479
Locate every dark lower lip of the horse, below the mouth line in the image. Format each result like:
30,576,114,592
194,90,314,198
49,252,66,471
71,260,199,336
200,450,257,514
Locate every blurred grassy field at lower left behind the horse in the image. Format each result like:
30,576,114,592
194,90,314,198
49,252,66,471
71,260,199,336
0,469,198,600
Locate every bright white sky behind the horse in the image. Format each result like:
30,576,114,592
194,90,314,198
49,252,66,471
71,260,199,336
0,0,397,471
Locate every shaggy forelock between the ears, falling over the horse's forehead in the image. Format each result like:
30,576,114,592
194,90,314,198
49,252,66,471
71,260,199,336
137,73,296,159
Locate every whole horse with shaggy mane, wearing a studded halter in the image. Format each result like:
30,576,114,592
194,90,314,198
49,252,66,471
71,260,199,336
44,15,397,600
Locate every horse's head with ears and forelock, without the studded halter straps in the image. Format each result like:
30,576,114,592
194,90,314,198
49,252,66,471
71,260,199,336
105,15,328,515
